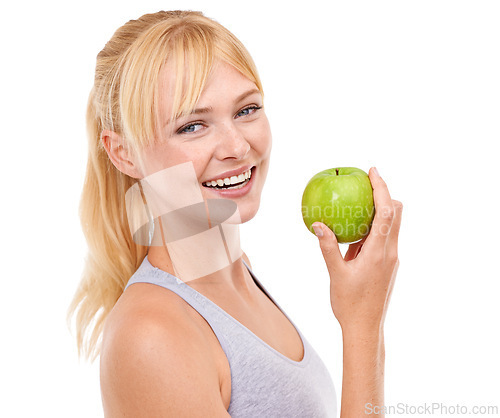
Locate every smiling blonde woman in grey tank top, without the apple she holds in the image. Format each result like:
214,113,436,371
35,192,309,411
70,11,402,417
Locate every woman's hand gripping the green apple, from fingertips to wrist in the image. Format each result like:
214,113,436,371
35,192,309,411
313,168,403,333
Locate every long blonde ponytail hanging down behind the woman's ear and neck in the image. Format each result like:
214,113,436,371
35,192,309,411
68,92,147,362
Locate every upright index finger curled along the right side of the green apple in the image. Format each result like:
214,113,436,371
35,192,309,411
368,167,394,244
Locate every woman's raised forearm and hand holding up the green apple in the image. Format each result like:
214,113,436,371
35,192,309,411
313,168,403,418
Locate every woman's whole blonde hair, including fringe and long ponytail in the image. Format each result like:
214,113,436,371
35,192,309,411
67,10,263,362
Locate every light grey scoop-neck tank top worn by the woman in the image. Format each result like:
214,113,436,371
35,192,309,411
125,256,337,418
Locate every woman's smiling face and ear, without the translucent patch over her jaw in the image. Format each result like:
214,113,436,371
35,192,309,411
138,61,272,223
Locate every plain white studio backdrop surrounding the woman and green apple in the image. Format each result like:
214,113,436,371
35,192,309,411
0,0,500,417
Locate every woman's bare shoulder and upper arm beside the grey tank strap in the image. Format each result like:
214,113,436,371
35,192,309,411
100,283,229,417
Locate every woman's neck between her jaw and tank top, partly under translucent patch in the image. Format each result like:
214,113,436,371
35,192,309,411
143,193,258,296
